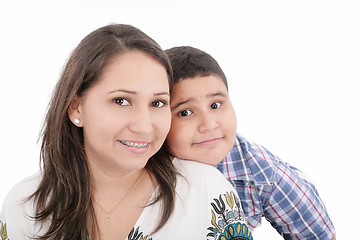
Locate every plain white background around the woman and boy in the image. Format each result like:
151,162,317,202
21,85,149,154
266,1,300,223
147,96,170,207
0,0,360,239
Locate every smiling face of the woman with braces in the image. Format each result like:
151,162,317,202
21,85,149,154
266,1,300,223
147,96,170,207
72,51,171,173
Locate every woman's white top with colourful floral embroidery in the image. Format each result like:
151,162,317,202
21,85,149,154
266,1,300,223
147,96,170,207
0,158,252,240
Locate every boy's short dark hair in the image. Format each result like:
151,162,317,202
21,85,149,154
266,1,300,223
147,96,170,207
165,46,228,89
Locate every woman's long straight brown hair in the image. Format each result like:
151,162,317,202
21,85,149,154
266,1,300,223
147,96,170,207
28,24,176,239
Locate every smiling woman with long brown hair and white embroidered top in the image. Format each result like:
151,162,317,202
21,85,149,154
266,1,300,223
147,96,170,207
0,25,251,239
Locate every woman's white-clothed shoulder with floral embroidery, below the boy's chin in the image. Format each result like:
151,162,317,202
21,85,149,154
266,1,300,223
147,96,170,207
167,158,252,239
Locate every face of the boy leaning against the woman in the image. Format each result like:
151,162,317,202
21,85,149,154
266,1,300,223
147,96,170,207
166,75,236,165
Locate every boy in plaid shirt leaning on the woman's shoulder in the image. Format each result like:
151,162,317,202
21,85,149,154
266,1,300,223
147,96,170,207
166,47,335,239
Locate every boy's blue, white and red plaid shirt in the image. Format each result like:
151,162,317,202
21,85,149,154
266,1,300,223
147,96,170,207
217,135,335,239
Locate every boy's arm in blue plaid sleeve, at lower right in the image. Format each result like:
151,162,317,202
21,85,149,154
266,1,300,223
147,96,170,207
264,161,336,239
